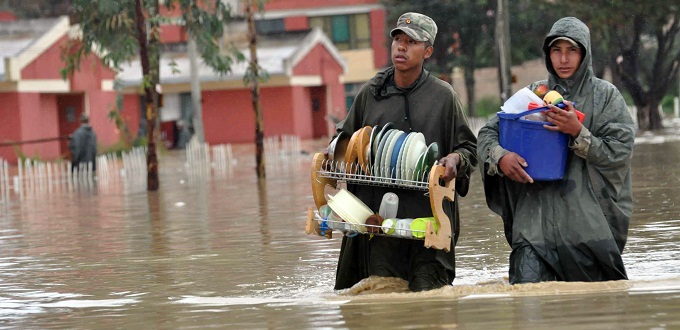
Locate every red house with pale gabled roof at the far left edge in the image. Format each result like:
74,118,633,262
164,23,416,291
0,17,119,163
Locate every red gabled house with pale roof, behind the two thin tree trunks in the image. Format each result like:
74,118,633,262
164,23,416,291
119,30,345,144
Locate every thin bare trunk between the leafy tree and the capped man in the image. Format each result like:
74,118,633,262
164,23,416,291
246,0,266,179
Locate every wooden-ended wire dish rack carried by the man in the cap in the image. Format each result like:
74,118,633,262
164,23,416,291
305,153,455,251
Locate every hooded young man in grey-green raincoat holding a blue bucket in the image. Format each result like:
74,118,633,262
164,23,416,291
477,17,635,284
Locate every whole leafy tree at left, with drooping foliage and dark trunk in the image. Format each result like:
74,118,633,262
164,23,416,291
62,0,239,191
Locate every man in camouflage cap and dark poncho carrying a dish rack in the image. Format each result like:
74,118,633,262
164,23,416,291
326,12,477,291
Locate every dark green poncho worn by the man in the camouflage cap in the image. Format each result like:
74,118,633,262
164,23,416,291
336,67,477,289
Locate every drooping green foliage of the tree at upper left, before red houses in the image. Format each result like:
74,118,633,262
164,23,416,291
62,0,242,78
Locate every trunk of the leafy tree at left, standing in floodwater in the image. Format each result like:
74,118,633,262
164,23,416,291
135,0,159,191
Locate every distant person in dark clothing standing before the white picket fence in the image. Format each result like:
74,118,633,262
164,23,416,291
68,113,97,173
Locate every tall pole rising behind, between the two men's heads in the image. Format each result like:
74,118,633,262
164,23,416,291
495,0,512,103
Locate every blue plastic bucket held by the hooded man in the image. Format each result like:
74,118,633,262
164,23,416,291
497,107,569,181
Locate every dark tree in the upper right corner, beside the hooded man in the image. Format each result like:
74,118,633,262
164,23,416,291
552,0,680,130
